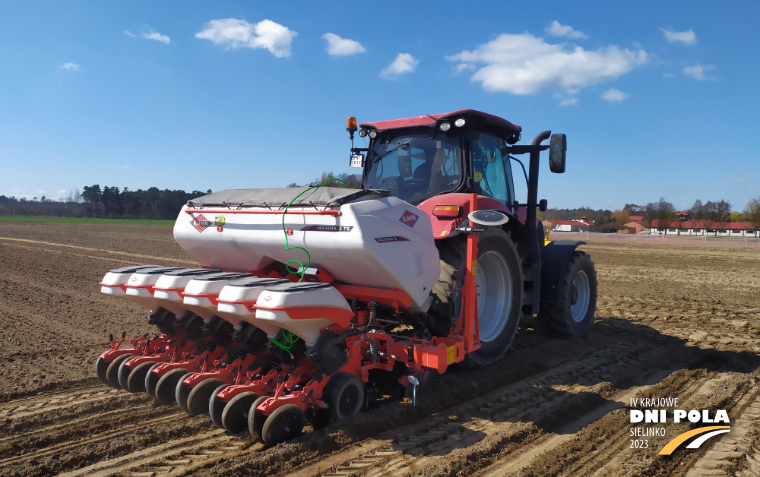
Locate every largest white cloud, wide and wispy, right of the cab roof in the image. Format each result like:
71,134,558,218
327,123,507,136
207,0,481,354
446,33,649,95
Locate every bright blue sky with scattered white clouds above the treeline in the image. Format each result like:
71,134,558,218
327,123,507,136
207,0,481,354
0,1,760,210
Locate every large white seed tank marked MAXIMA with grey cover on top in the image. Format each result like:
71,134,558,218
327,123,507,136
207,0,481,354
174,187,440,307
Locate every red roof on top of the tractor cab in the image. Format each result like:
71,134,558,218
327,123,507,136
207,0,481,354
359,109,522,136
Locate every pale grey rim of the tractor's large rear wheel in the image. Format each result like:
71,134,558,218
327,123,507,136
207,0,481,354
475,251,512,341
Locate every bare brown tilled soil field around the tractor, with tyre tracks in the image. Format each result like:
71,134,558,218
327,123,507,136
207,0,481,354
0,223,760,477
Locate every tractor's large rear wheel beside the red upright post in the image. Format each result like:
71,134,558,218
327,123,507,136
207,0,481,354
465,227,524,367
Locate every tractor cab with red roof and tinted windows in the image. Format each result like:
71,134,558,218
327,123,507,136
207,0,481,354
349,110,522,210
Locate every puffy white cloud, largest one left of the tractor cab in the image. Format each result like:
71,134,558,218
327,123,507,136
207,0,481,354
195,18,298,58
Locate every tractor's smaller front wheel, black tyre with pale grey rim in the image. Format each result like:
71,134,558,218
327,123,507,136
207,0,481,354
538,250,597,338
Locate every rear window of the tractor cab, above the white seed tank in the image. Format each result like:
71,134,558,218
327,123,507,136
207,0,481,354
367,134,462,205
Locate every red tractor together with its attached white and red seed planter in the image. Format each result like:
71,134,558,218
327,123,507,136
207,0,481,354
96,110,597,445
